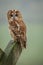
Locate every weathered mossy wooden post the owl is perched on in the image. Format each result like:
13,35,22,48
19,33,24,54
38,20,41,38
0,40,22,65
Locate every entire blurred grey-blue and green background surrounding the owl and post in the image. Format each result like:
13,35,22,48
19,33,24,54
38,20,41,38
0,0,43,65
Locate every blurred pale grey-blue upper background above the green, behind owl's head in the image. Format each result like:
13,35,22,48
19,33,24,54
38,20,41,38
0,0,43,24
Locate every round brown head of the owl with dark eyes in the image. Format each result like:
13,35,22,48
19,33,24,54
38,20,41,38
7,10,22,22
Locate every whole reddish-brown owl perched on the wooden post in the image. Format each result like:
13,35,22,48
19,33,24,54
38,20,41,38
7,10,26,48
